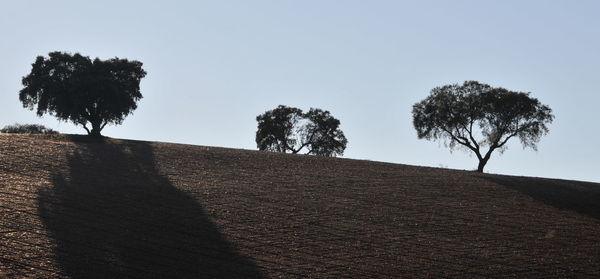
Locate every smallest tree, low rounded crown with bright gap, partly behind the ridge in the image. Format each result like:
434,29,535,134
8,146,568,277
256,105,348,157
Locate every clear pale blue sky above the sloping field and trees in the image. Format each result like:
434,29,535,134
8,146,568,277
0,0,600,182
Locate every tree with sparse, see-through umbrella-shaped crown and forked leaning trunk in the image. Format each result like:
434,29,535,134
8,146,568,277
412,81,554,172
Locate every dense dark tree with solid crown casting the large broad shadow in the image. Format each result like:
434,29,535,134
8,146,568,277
19,52,146,136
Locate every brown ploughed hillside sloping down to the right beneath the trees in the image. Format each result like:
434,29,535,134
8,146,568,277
0,135,600,278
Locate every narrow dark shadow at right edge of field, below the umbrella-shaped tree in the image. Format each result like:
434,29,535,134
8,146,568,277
481,176,600,220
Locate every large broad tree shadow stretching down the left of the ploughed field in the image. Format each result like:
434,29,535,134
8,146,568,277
39,137,261,278
